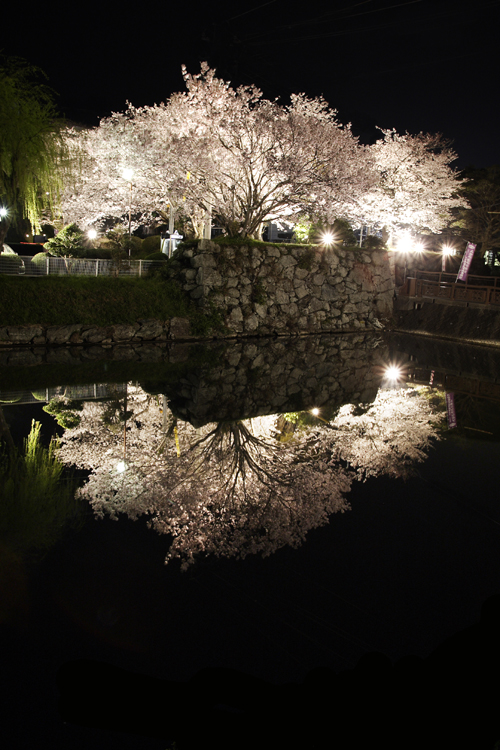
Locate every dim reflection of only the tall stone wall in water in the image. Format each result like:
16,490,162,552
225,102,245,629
166,333,387,427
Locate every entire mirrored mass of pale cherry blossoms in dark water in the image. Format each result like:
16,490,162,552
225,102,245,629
59,387,442,568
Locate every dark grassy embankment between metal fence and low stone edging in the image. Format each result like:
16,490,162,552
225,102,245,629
0,275,223,335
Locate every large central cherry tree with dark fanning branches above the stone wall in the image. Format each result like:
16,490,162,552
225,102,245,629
160,64,372,237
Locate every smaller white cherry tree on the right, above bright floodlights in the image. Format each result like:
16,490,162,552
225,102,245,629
363,130,464,241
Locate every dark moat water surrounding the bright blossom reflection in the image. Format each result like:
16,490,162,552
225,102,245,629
0,336,500,750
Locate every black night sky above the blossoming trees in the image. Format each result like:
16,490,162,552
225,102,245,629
0,0,500,168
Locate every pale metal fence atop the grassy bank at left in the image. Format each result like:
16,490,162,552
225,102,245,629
0,255,167,276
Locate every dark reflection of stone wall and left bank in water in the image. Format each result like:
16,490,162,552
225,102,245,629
0,332,388,426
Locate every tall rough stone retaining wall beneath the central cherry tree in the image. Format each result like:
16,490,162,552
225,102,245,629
172,241,394,335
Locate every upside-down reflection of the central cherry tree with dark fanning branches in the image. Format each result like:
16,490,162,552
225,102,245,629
145,422,351,567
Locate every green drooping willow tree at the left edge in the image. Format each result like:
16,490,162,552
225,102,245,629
0,58,68,252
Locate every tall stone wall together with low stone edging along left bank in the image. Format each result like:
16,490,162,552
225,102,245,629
0,241,394,348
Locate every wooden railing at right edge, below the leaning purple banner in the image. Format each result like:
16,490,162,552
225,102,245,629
399,271,500,305
